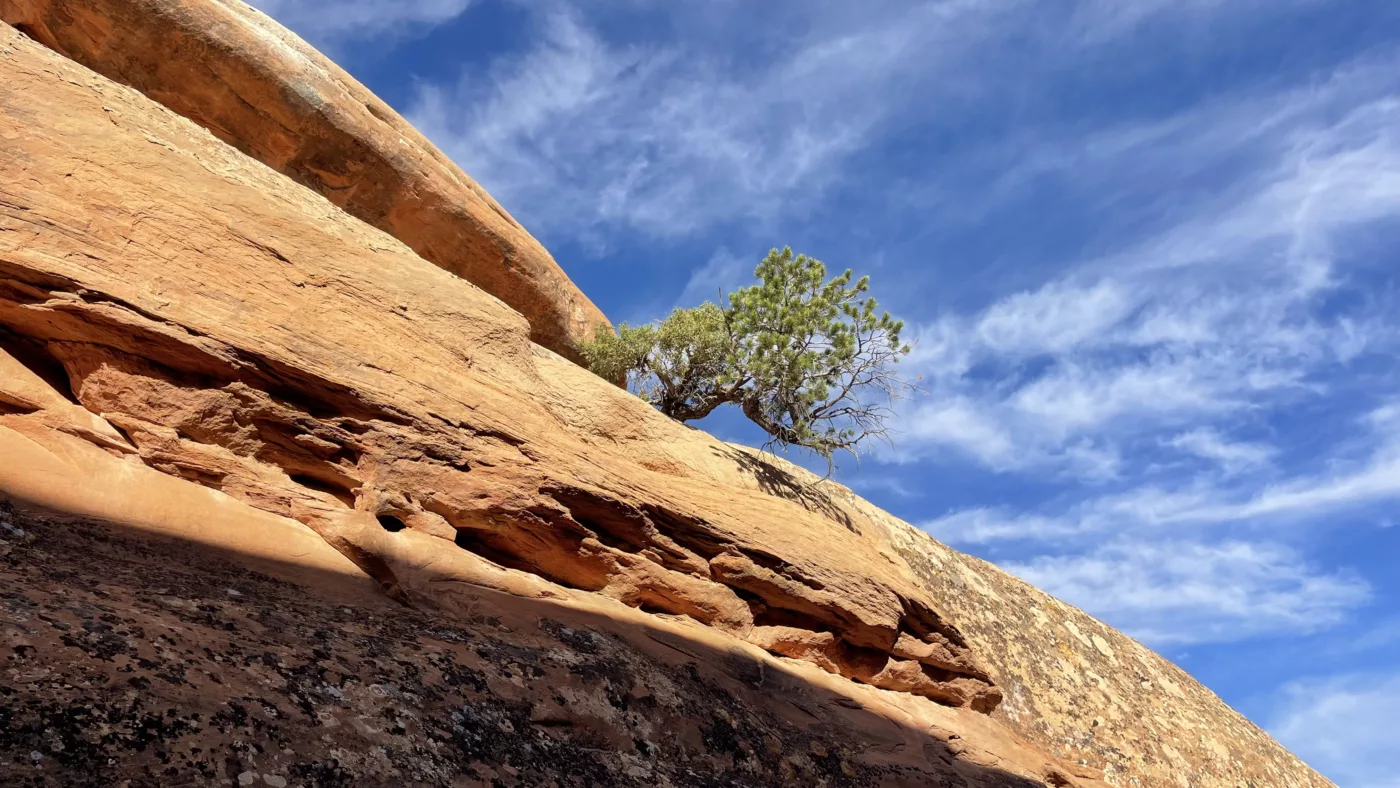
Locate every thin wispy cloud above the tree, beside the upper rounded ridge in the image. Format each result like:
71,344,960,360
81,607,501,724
406,0,1321,248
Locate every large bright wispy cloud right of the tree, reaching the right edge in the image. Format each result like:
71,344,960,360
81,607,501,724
900,59,1400,472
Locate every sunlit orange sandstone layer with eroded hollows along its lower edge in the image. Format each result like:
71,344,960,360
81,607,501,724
0,12,997,710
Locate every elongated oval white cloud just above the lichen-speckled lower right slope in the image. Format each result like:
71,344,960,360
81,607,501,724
1002,540,1371,647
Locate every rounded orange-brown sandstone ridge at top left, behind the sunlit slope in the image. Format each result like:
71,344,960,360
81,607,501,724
0,0,608,360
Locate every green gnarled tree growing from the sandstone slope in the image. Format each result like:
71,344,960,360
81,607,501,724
584,248,911,470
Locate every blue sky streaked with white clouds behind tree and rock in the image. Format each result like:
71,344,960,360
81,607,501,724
259,0,1400,788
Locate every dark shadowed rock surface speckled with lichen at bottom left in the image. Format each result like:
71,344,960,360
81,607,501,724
0,504,1088,788
